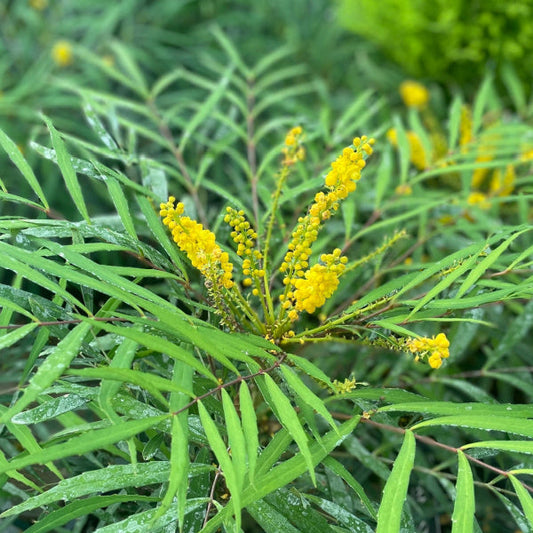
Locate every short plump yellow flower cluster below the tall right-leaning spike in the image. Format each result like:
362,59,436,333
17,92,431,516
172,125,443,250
288,248,348,318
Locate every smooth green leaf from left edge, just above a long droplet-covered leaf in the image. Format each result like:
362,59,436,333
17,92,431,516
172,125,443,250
0,415,168,474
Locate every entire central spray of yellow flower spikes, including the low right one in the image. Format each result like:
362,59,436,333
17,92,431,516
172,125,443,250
160,130,449,368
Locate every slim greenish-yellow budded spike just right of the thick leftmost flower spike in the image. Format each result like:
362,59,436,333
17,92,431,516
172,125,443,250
224,207,265,287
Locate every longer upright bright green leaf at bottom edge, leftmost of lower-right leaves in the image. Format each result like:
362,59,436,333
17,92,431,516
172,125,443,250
376,430,416,533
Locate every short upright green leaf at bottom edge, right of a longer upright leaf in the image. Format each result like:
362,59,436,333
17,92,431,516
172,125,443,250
452,450,476,533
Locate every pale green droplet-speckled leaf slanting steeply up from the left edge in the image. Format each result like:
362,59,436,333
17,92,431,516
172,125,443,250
0,324,91,424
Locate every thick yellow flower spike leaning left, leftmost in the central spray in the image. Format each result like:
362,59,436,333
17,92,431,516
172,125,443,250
159,196,233,290
